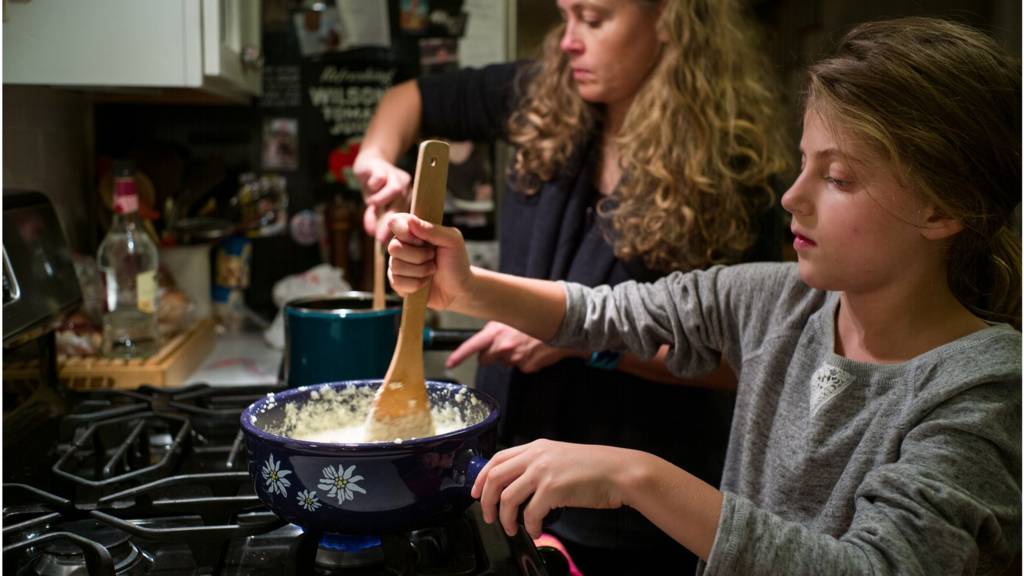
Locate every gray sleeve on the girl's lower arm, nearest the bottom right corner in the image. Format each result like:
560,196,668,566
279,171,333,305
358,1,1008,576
703,375,1021,576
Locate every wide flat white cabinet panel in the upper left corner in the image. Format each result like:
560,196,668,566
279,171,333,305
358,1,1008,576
3,0,201,87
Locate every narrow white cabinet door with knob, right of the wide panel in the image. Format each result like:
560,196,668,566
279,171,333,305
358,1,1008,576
203,0,263,95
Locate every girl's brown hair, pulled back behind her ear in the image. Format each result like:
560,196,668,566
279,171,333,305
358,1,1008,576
807,17,1021,330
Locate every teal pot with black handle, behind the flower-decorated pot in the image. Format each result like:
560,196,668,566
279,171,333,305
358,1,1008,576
282,292,474,387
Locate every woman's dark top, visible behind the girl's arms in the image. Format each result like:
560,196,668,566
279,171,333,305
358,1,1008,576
419,63,774,566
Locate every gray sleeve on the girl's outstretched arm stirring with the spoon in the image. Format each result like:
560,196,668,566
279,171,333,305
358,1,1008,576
551,263,807,376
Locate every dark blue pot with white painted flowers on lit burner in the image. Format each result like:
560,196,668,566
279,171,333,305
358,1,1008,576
242,380,499,534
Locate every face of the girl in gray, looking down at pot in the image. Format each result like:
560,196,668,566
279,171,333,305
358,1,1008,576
782,108,935,293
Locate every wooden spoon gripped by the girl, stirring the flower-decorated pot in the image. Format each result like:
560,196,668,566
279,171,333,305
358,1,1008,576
365,140,449,442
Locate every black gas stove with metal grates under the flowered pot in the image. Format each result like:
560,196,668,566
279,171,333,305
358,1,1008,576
3,384,567,576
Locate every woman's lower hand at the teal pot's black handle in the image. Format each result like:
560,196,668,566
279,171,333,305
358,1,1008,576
444,322,582,374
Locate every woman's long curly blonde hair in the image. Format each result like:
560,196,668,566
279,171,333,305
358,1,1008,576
509,0,788,271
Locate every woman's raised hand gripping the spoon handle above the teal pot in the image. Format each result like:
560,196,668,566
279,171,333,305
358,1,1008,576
352,151,412,243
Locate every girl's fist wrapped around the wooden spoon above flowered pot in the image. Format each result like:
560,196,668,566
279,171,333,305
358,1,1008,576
387,213,473,310
